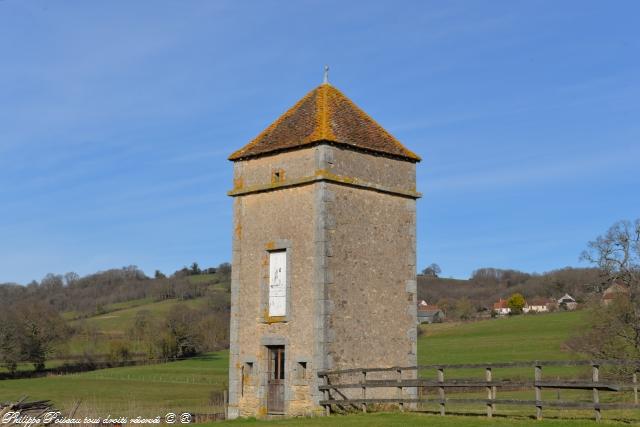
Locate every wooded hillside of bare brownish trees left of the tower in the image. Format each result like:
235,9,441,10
0,263,231,372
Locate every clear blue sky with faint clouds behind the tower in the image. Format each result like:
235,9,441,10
0,0,640,283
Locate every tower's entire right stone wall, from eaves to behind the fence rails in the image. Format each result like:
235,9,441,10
320,146,417,397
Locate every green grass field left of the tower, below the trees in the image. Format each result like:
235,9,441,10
0,351,229,415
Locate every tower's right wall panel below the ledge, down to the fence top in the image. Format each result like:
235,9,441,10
328,185,416,369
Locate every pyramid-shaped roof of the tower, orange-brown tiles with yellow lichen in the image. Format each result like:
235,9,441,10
229,84,420,162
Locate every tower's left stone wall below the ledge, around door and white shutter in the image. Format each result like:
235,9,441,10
230,168,316,416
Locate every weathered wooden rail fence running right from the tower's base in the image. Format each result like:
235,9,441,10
318,360,640,421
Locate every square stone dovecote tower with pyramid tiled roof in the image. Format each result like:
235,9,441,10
229,83,420,418
